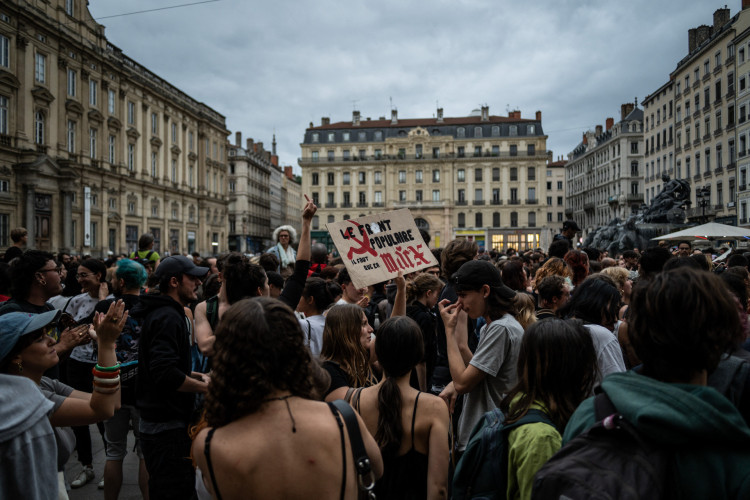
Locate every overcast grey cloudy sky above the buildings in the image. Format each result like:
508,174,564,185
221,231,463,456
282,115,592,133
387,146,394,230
89,0,741,170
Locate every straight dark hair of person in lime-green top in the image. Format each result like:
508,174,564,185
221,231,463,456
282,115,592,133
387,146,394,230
502,318,597,432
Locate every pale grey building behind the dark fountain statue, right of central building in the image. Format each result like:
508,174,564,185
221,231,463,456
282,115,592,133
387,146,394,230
565,103,643,232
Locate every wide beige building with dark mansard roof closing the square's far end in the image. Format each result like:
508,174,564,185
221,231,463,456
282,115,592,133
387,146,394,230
299,106,556,250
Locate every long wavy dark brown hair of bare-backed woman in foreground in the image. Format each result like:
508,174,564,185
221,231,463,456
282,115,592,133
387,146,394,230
205,297,316,427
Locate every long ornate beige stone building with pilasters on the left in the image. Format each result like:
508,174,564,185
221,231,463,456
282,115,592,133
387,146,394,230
0,0,229,256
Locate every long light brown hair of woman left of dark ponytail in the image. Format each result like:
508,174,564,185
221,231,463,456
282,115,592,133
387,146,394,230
320,304,370,387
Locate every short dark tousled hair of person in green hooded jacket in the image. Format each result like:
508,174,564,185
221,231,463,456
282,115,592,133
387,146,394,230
628,267,742,382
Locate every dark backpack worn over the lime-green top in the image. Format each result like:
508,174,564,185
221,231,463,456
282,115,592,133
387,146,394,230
451,409,554,500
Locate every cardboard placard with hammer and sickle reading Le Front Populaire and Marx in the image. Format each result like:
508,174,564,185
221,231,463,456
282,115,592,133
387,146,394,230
326,208,439,288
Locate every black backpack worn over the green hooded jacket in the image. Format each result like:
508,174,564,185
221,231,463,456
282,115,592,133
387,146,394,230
531,392,679,500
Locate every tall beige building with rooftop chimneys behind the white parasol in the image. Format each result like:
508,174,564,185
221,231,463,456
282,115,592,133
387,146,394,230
668,2,750,225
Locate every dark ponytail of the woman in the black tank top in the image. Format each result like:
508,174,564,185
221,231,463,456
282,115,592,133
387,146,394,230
375,316,424,456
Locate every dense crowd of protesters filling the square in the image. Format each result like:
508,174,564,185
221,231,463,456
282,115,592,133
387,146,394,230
0,212,750,500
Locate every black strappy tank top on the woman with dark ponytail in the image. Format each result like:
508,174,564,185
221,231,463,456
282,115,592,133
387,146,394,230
375,392,428,500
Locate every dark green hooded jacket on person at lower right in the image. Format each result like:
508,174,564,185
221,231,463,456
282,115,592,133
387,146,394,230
563,371,750,499
